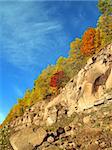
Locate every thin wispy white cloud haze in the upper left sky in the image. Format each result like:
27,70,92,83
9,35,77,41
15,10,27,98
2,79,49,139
0,3,62,69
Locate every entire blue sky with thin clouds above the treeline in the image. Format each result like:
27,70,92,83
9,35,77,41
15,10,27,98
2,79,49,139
0,0,100,122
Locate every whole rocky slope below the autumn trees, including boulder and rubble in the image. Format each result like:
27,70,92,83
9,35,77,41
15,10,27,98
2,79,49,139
1,44,112,150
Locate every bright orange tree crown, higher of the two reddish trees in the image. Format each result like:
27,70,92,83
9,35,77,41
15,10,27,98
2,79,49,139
81,28,96,56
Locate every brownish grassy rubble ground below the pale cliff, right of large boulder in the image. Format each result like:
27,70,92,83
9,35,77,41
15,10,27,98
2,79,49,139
33,103,112,150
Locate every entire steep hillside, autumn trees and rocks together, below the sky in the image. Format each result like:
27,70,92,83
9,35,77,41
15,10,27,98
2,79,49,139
0,0,112,150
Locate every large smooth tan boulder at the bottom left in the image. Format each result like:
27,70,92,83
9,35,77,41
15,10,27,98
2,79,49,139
10,127,47,150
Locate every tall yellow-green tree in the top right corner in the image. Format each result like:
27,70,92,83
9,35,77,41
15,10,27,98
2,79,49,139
97,0,112,47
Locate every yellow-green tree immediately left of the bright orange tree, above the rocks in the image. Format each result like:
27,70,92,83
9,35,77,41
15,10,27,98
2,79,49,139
63,38,86,79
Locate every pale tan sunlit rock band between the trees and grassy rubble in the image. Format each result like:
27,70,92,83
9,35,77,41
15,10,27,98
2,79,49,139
10,44,112,135
